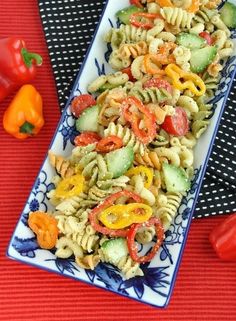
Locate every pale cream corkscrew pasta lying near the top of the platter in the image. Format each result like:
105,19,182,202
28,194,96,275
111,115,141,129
160,7,194,29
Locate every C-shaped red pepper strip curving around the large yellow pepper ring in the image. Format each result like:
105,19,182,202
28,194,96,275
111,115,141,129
89,190,142,237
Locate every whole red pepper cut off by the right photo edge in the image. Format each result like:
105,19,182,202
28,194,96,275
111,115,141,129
209,213,236,261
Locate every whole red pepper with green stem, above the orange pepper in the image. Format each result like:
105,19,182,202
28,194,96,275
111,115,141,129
0,37,42,102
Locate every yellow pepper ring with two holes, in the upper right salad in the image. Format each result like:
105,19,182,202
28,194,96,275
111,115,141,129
165,64,206,96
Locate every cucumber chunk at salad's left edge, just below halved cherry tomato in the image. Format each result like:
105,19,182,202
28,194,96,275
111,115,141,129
76,105,99,132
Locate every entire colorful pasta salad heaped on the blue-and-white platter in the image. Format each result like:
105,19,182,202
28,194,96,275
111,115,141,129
28,0,236,279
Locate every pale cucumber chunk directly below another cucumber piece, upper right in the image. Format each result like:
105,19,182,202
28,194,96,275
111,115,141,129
190,46,217,73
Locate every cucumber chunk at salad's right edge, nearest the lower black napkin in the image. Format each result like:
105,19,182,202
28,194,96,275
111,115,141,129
162,163,190,192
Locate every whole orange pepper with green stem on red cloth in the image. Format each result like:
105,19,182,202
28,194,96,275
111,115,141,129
3,85,44,139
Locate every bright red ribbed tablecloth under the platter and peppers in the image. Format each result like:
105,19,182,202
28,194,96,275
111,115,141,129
0,0,236,321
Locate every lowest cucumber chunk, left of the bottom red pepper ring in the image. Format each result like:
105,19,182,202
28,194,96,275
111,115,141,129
101,237,128,265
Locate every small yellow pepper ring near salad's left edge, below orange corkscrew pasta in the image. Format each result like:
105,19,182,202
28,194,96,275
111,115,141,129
55,174,84,198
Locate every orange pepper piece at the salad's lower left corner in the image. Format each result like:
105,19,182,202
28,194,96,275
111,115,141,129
28,211,59,250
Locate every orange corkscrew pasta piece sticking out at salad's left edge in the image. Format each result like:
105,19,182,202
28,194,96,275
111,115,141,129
48,150,75,178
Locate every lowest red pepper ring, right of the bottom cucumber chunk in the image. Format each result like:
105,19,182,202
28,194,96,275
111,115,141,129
127,217,164,263
